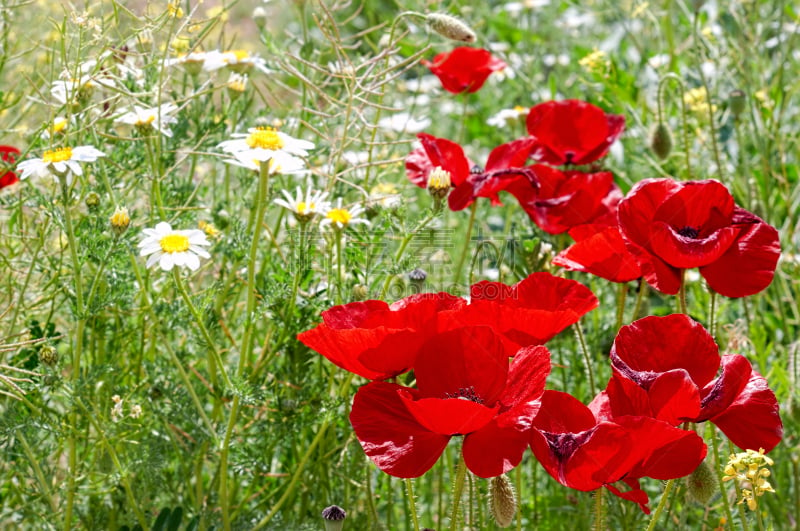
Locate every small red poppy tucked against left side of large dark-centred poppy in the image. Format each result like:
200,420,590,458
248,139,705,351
553,223,642,282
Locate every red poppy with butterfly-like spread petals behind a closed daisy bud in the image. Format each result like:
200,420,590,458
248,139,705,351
406,133,538,211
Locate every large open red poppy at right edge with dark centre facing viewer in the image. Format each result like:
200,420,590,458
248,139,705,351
619,179,781,297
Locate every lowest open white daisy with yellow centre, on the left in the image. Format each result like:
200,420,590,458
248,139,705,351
138,221,211,271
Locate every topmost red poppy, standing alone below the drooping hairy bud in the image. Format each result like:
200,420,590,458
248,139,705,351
422,46,506,94
